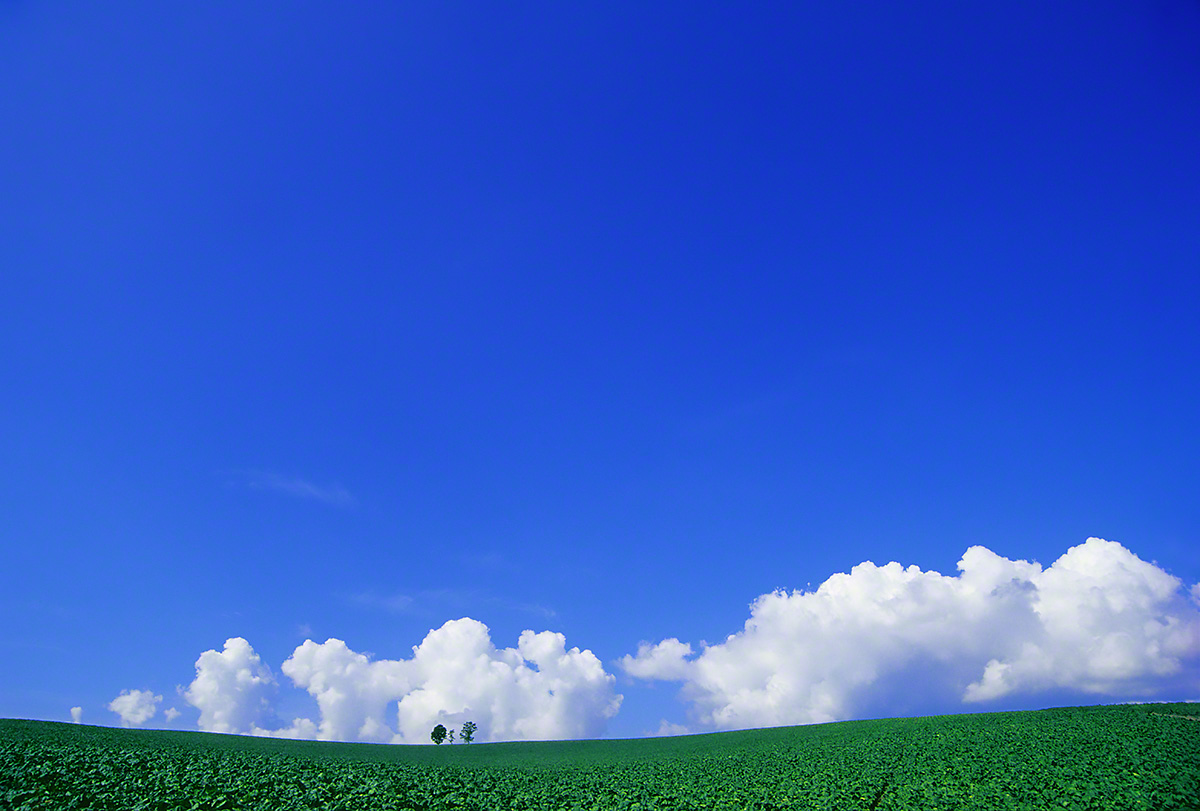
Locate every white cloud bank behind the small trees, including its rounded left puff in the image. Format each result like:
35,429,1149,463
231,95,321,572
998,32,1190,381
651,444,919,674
185,618,622,744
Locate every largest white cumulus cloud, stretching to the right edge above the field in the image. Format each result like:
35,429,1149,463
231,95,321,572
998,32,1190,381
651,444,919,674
622,537,1200,729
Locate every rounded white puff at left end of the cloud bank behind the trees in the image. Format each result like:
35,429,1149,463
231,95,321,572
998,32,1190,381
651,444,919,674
184,637,277,732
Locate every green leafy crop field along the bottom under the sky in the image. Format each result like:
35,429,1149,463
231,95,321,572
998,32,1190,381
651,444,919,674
0,704,1200,811
